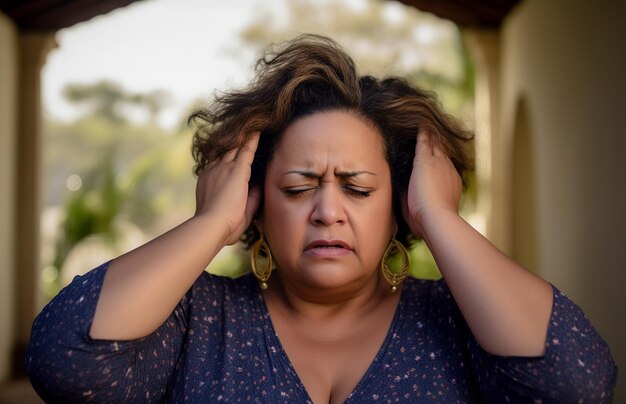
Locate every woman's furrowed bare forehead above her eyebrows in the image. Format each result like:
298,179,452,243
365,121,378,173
272,111,388,170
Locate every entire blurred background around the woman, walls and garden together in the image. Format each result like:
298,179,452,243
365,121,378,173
0,0,626,403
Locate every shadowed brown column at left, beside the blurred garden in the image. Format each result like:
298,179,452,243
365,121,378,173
13,33,56,374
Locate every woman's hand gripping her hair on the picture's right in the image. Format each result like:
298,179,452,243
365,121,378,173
403,129,462,238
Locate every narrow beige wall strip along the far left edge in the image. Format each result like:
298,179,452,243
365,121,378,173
0,13,18,383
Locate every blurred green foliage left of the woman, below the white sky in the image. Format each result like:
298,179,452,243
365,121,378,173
42,82,194,298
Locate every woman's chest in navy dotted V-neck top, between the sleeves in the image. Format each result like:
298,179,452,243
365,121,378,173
168,280,478,403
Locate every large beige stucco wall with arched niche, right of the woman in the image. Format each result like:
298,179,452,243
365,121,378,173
494,0,626,402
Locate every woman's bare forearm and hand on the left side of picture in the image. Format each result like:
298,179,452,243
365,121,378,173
90,134,259,340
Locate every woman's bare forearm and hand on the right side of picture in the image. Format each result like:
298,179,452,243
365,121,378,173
404,131,552,356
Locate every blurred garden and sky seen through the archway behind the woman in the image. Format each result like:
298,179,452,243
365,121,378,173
40,0,475,302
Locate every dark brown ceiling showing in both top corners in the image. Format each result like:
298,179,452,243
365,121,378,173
0,0,519,32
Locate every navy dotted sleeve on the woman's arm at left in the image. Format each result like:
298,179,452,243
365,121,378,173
26,263,188,403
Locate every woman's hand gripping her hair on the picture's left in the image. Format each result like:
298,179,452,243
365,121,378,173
194,132,261,245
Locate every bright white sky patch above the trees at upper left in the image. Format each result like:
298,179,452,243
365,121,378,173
42,0,280,126
